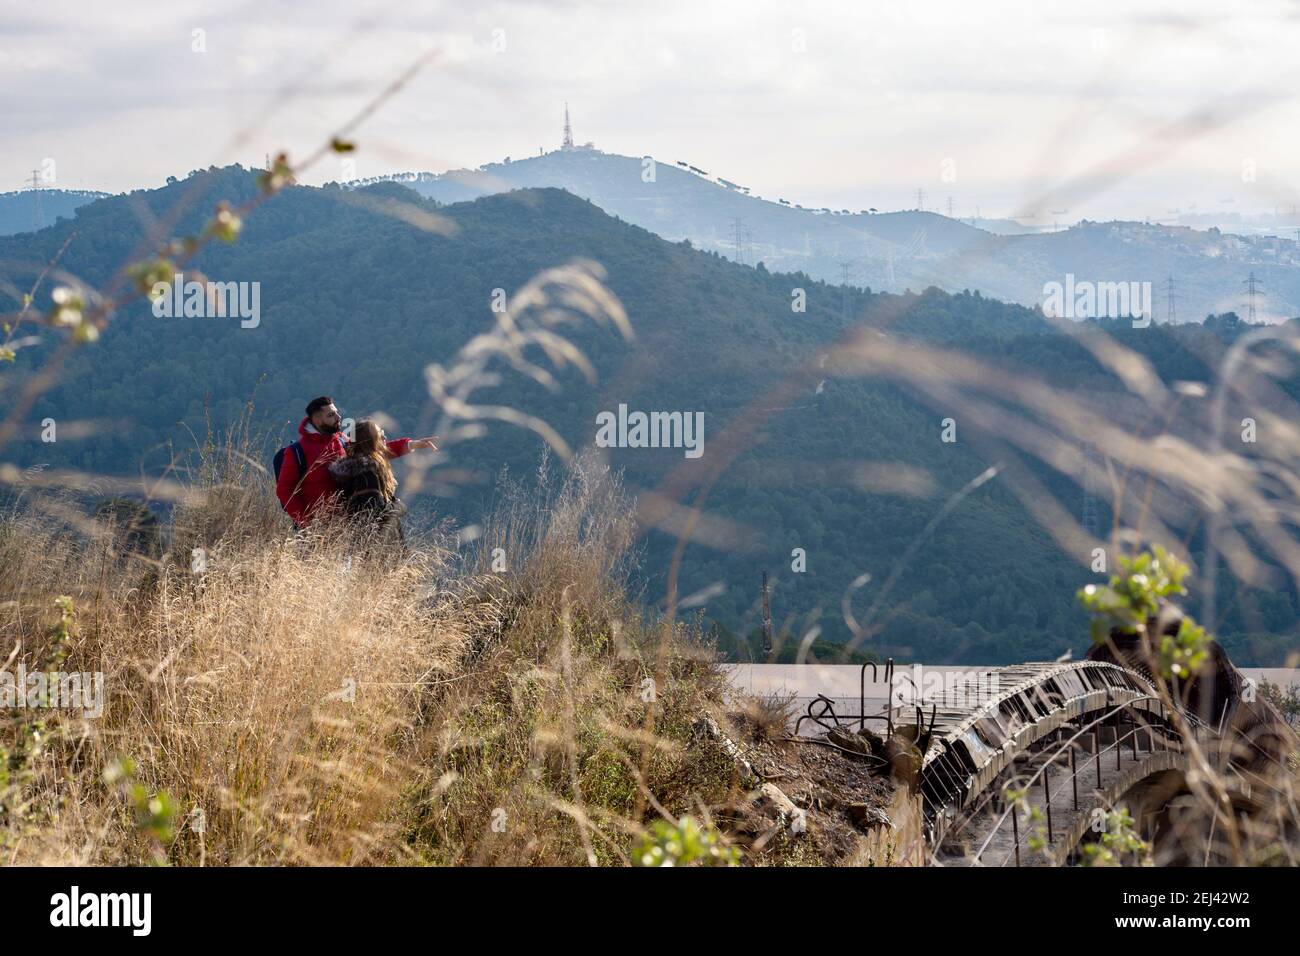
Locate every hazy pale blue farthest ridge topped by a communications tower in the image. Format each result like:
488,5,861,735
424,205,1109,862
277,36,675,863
356,147,1300,323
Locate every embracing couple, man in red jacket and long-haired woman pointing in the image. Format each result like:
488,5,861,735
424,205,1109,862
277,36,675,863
273,395,438,540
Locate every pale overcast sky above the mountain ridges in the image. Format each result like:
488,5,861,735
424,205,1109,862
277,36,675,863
0,0,1300,221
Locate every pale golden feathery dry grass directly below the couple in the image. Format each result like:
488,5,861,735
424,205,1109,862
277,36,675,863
7,494,471,864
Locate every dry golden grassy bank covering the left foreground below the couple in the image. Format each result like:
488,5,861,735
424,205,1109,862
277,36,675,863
0,450,754,865
